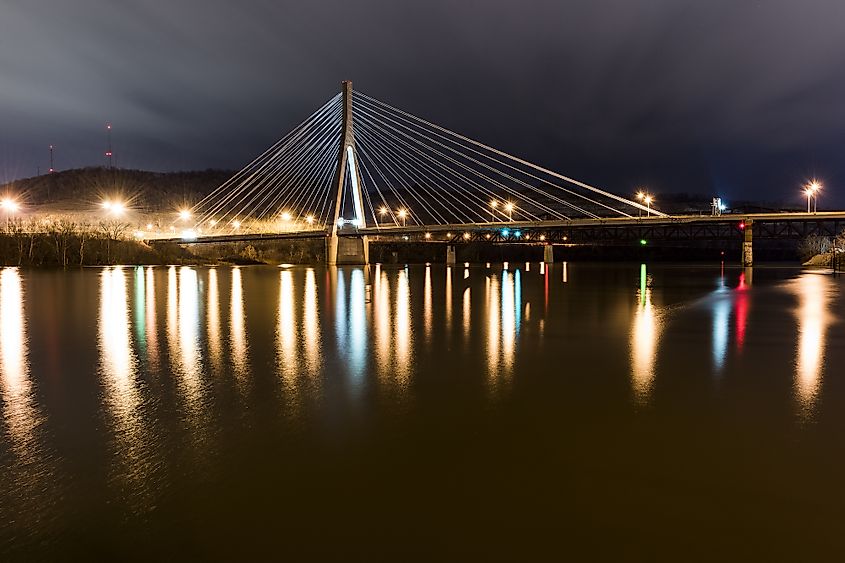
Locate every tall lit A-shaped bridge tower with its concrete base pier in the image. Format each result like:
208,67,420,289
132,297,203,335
326,80,369,265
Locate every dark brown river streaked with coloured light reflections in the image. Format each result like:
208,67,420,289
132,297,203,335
0,263,845,561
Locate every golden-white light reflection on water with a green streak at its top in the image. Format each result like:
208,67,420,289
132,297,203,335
631,264,661,403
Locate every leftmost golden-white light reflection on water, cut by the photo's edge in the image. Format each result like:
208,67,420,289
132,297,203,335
0,268,39,456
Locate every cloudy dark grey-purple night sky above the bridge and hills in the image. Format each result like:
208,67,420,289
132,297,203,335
0,0,845,209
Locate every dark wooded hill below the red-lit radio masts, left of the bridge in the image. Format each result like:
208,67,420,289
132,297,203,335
0,168,234,211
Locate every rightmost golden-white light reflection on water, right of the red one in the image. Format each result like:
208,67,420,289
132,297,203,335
793,274,833,419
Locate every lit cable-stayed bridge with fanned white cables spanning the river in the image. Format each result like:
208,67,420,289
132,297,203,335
165,82,845,264
